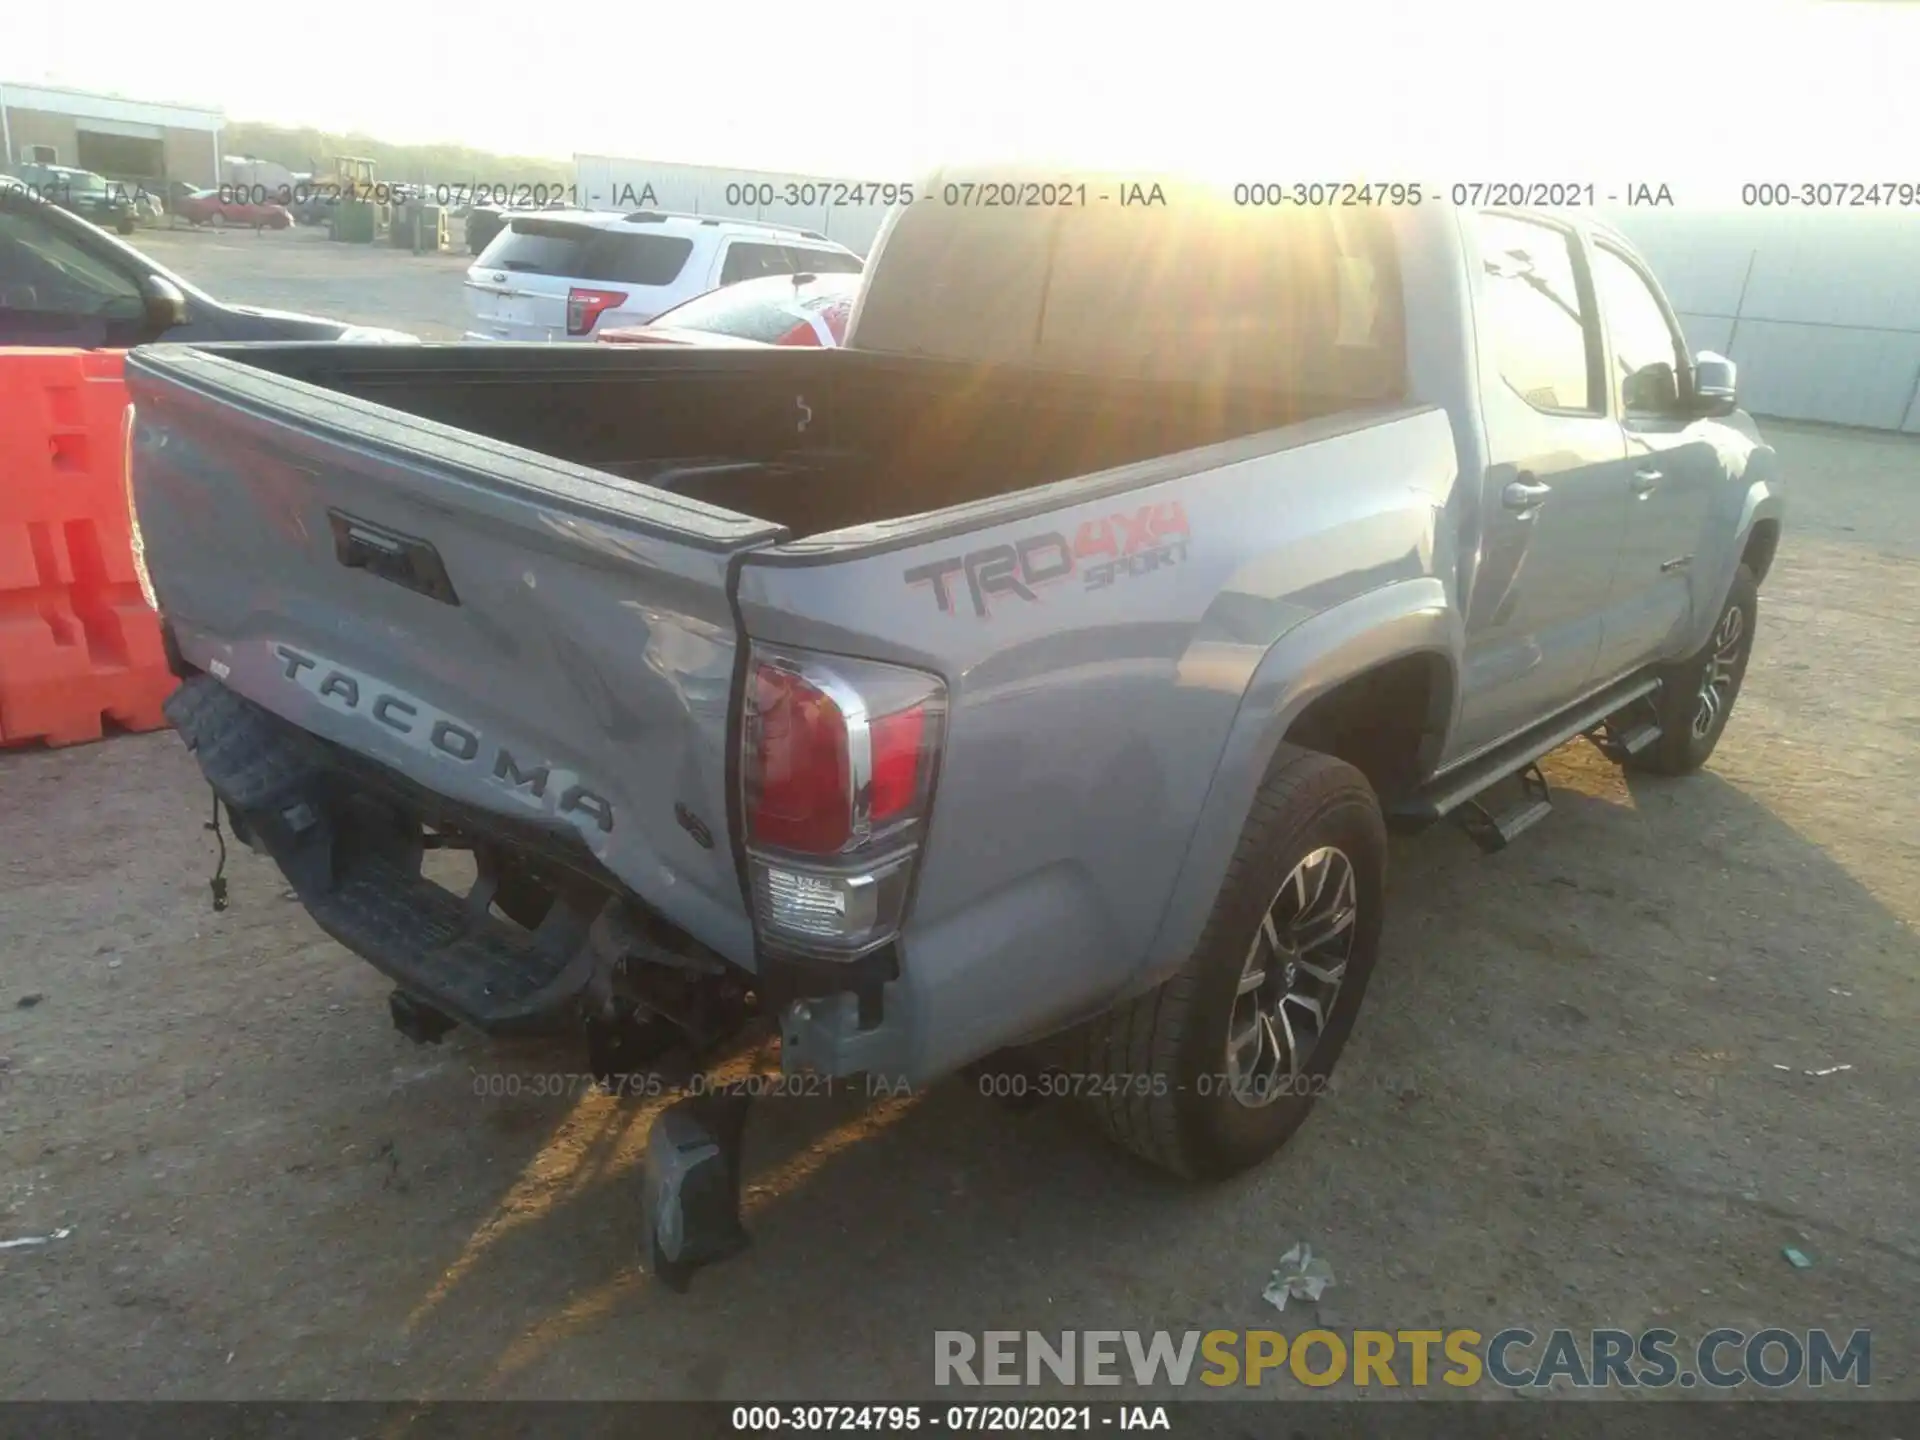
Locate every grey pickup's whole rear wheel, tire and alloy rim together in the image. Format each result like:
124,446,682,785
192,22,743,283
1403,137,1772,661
1069,745,1386,1179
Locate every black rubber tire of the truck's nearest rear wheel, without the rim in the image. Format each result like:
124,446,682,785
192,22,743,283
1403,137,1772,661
1068,745,1386,1179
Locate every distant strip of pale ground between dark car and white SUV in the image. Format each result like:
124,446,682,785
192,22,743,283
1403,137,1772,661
129,221,472,340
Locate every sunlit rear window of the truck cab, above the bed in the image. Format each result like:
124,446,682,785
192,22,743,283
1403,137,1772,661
856,186,1405,403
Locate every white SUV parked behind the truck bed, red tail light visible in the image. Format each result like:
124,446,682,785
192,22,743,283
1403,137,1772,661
467,209,862,340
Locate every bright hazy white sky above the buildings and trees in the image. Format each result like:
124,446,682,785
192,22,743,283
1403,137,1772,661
0,0,1920,196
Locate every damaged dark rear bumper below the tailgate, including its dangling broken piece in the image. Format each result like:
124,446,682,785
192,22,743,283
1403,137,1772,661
167,676,779,1292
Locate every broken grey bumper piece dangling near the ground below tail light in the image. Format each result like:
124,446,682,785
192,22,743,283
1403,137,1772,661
641,1091,749,1294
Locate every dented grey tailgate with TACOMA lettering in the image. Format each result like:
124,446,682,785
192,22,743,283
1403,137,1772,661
127,346,783,966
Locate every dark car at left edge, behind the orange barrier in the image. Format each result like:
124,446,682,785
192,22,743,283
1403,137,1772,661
0,184,415,349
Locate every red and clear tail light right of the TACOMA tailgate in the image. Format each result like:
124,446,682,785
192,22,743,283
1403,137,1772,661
741,647,947,958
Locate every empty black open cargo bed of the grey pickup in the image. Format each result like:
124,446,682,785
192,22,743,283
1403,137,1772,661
209,344,1352,540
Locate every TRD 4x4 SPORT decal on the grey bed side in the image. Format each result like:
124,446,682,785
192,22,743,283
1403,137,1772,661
902,499,1188,616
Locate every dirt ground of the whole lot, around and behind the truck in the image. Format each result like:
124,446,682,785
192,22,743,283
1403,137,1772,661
0,378,1920,1398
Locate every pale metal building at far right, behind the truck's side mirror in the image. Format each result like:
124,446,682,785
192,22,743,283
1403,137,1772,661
1609,209,1920,434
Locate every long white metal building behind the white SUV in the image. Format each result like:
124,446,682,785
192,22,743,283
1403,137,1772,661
574,156,887,255
